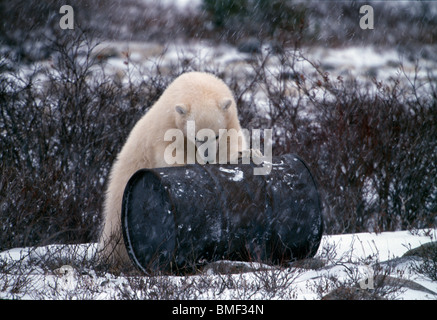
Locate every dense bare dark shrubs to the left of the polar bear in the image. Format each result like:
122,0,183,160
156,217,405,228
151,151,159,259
0,31,168,249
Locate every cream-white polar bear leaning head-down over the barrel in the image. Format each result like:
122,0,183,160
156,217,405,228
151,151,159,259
99,72,246,266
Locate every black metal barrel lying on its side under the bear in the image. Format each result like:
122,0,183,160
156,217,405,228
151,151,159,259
121,154,323,273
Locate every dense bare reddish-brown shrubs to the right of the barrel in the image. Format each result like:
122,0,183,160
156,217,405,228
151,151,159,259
237,50,437,234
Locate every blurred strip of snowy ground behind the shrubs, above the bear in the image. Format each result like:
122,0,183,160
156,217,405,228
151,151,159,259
5,34,430,93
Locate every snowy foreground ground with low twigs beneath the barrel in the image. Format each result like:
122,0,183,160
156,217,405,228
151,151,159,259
0,229,437,300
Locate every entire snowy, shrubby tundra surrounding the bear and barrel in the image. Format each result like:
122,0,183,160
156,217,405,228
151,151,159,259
0,0,437,299
